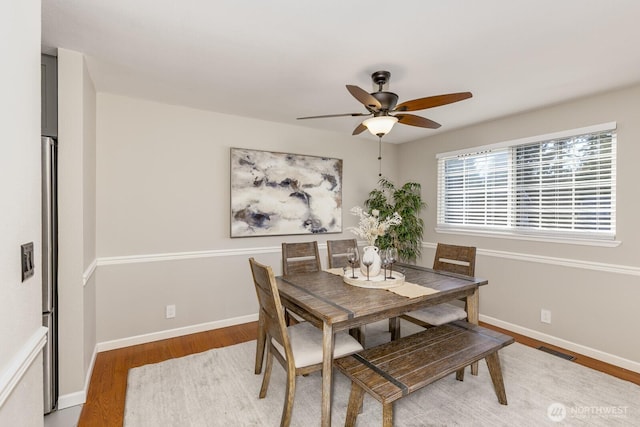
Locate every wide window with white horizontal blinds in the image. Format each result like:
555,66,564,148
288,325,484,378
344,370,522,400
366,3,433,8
437,123,616,244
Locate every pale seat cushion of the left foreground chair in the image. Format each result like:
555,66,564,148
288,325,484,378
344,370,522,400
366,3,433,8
272,322,363,368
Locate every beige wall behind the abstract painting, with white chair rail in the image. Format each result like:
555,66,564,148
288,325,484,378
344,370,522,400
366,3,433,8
97,93,396,342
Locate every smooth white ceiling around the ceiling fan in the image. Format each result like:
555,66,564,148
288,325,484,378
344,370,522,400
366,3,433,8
42,0,640,143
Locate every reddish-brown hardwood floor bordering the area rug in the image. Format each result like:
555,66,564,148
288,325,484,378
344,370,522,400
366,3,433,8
78,322,640,427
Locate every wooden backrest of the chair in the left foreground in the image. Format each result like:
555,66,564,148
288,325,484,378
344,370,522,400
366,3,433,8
249,258,293,361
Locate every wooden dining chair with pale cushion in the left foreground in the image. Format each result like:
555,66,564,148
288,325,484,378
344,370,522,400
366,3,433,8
249,258,363,426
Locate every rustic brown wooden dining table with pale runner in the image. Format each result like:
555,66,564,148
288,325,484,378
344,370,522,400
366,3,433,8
276,264,488,426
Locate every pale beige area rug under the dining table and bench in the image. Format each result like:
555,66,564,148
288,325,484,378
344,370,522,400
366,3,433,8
124,322,640,427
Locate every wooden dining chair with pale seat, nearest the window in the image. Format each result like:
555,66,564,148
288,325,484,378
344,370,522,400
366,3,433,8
400,243,476,328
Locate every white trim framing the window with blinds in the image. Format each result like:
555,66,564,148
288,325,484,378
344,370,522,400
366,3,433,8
434,122,622,247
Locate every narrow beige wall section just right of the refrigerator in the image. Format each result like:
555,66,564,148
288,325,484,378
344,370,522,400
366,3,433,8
58,49,96,408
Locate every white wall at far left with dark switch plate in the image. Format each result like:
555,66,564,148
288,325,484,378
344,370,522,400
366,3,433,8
0,0,46,427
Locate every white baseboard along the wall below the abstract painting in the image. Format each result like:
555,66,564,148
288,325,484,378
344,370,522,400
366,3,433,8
96,313,258,352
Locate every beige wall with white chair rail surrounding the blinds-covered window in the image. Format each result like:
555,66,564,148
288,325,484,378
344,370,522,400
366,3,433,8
399,86,640,370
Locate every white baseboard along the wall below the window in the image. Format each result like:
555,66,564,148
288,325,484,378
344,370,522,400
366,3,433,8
480,314,640,373
